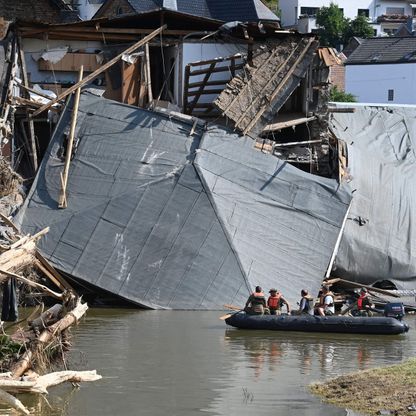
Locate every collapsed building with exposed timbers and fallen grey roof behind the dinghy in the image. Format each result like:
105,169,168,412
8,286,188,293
2,11,416,309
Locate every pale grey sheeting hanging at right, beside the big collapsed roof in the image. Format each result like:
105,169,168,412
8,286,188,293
331,104,416,289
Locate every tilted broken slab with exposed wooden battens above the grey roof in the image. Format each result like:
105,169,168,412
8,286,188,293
214,36,318,136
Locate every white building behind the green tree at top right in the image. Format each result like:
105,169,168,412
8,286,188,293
279,0,416,36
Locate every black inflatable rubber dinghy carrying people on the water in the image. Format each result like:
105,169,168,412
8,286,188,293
225,312,409,335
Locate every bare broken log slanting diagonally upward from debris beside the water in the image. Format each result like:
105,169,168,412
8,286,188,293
10,301,88,379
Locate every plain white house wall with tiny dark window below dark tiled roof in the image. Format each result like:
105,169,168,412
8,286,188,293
345,63,416,104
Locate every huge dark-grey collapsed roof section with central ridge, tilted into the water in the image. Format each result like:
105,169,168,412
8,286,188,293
20,93,349,309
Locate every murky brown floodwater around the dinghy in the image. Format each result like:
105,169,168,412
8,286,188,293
0,309,416,416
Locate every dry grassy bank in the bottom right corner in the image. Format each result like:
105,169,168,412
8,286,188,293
310,358,416,415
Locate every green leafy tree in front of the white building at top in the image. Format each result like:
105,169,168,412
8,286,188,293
316,3,374,48
